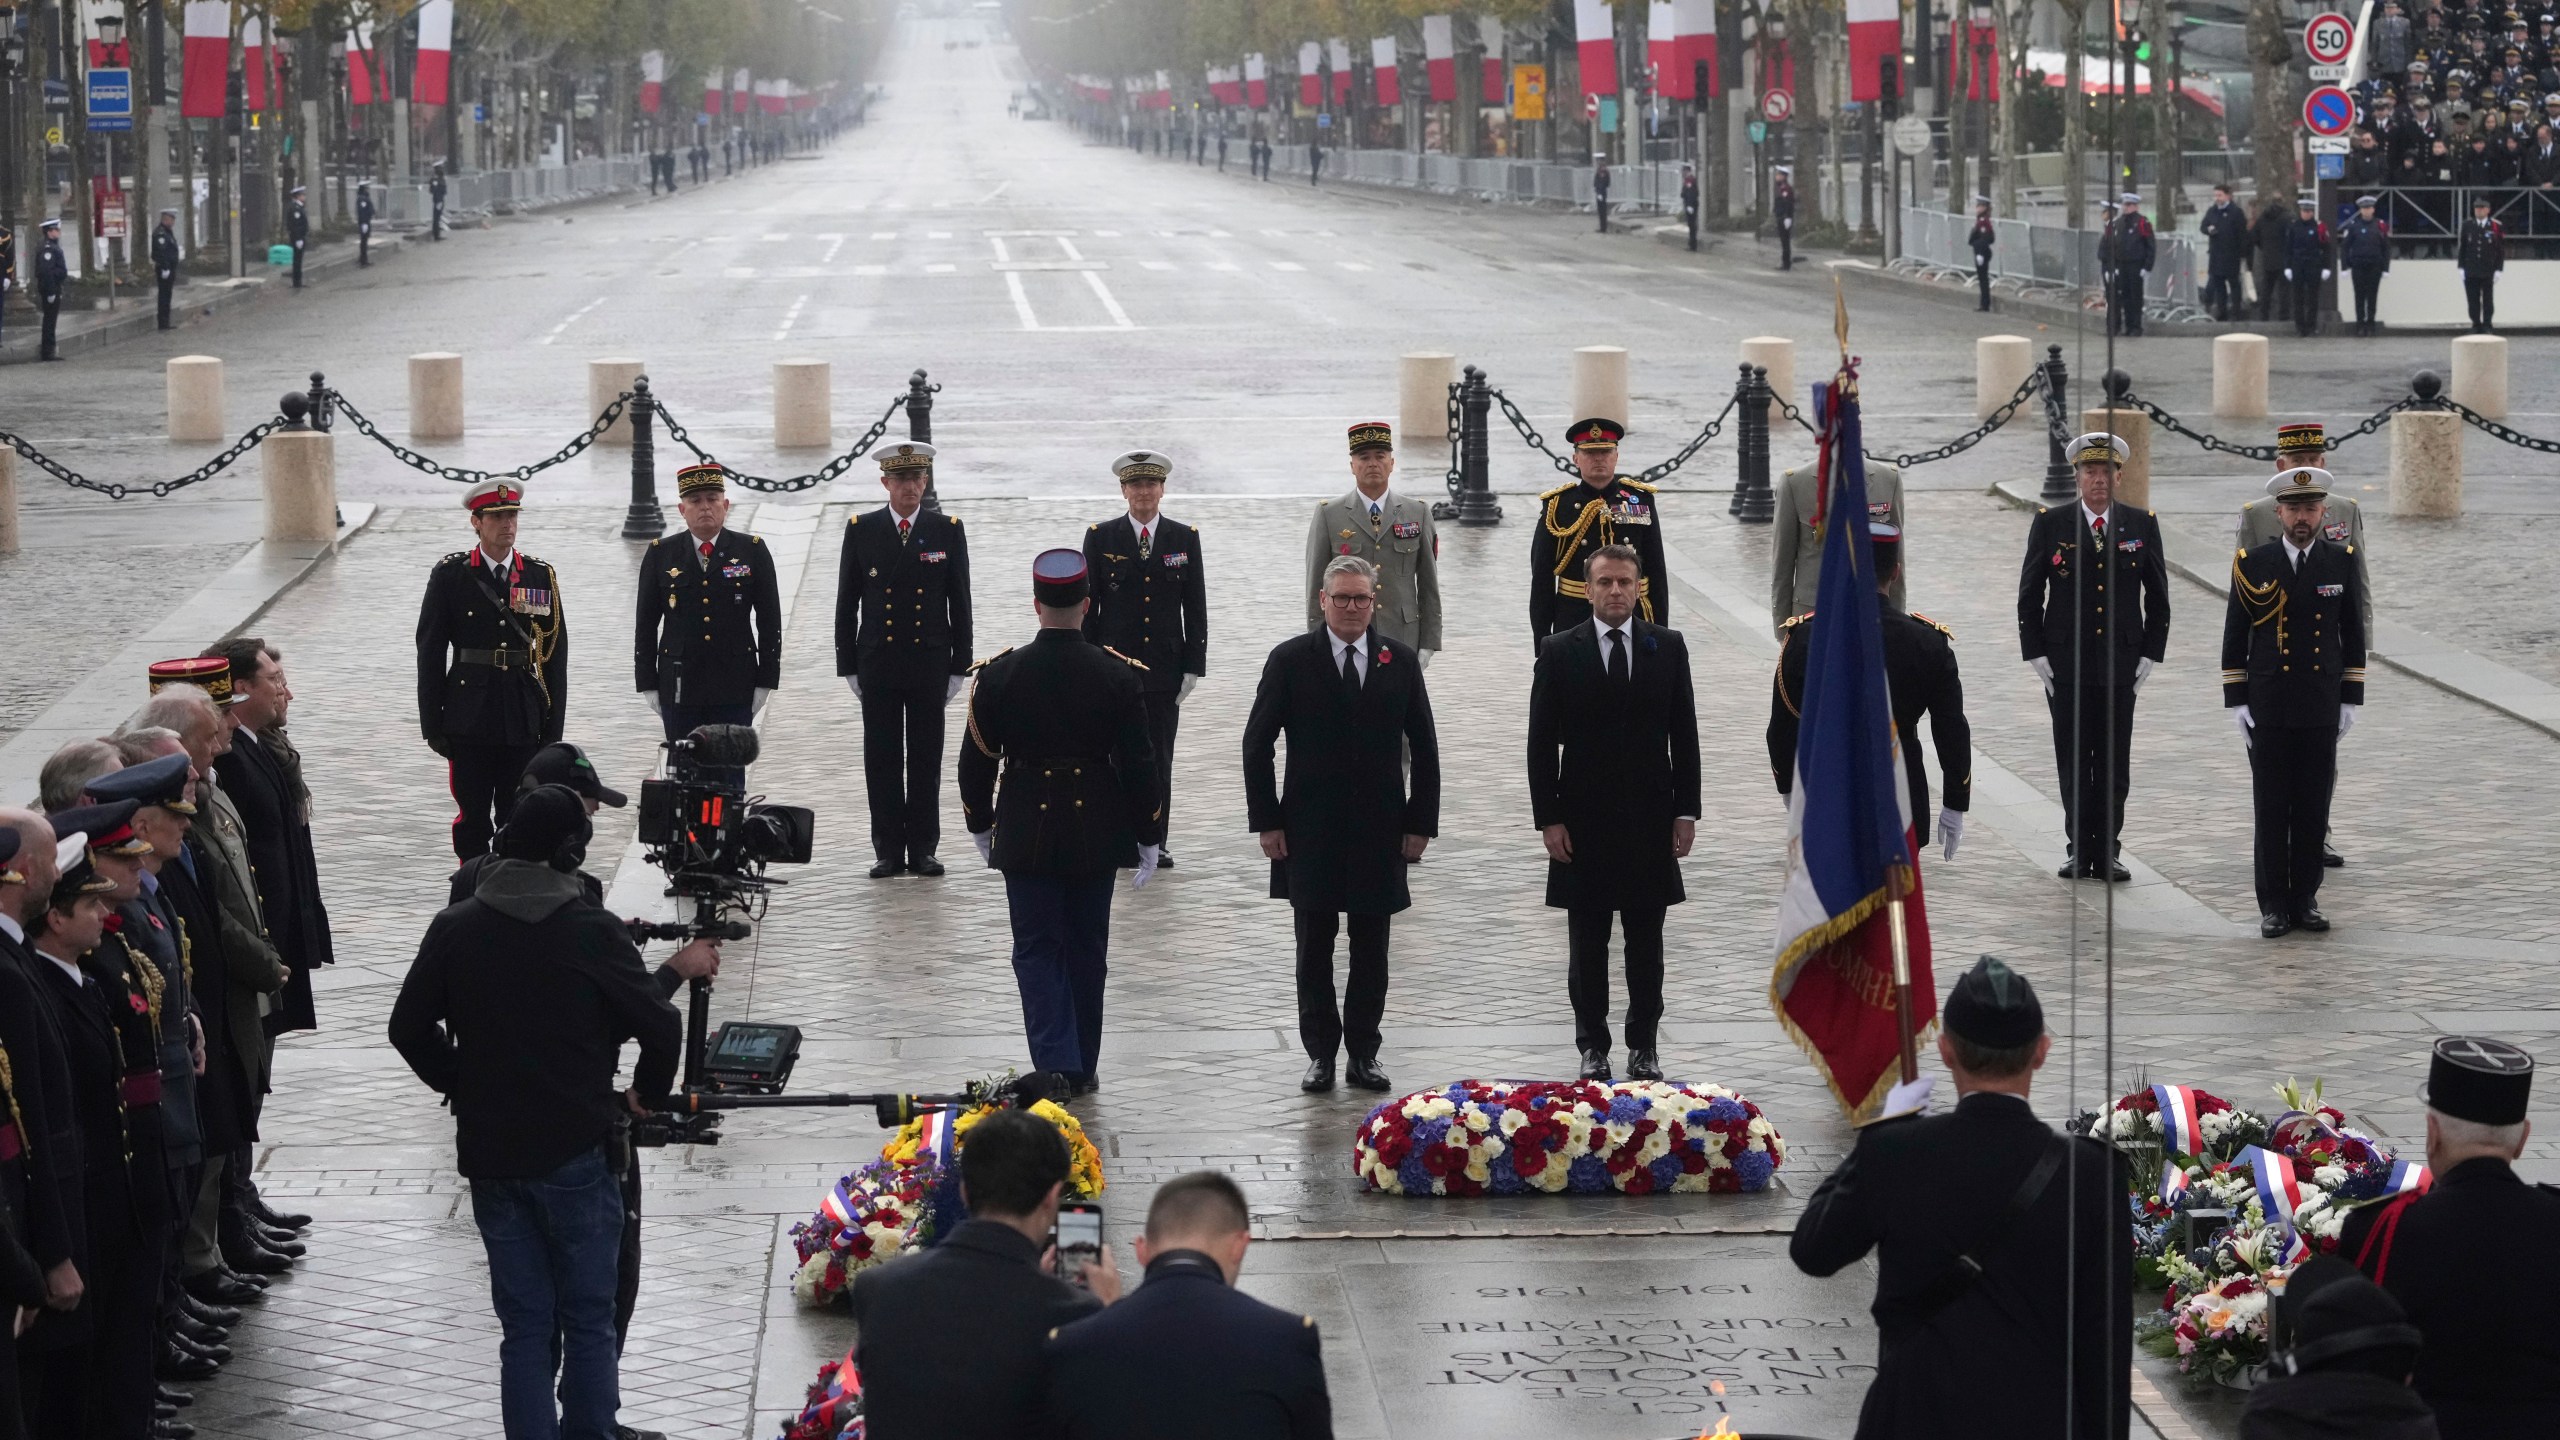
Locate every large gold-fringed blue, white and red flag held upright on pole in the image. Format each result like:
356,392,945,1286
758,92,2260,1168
1769,366,1938,1120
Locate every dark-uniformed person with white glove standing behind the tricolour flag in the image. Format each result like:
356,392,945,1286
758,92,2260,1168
1769,523,1974,861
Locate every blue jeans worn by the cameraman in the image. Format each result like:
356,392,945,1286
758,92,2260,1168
471,1148,622,1440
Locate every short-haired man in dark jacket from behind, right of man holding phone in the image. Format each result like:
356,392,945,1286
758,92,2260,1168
1047,1171,1334,1440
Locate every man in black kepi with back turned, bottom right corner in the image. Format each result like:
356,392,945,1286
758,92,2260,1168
2337,1035,2560,1440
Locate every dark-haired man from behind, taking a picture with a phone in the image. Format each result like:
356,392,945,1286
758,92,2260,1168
847,1109,1119,1440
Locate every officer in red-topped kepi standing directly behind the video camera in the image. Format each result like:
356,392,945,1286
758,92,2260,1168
632,461,783,740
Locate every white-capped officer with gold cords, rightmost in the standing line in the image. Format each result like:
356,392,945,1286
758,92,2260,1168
2222,466,2365,940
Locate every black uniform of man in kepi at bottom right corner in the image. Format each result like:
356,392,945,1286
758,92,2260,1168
2337,1156,2560,1440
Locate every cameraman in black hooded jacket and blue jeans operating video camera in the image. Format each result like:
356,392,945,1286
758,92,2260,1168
389,784,684,1440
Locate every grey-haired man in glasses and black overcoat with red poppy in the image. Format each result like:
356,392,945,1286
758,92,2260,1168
1244,556,1439,1094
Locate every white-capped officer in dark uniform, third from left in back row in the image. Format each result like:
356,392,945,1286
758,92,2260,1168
835,441,970,879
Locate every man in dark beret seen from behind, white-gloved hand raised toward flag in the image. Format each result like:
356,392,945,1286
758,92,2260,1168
1787,956,2132,1440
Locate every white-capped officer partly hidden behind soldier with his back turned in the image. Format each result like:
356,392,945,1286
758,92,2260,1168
1085,451,1208,869
